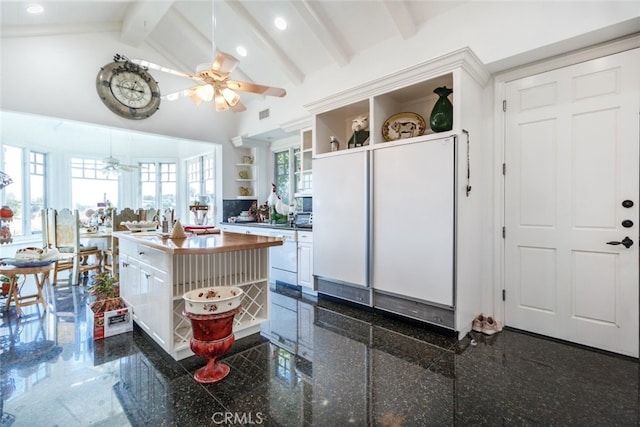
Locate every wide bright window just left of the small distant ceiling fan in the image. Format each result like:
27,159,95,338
71,157,118,212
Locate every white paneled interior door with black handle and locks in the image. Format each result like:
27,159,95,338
505,49,640,357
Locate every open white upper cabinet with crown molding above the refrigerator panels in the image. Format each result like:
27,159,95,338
306,48,489,157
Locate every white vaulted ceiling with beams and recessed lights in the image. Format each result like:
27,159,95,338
0,0,464,100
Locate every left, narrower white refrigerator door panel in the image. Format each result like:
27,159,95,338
313,151,368,286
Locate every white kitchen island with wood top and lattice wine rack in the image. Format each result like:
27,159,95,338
114,232,282,360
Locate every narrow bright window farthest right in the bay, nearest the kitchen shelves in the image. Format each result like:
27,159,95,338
187,155,216,225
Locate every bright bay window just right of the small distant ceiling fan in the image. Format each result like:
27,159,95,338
140,162,176,210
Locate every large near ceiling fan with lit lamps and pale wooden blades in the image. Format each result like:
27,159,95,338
131,0,287,112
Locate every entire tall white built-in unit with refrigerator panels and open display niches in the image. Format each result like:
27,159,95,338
307,49,491,337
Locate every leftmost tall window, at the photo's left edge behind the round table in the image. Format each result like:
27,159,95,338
2,145,47,237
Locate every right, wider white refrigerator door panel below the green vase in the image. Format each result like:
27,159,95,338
370,138,455,306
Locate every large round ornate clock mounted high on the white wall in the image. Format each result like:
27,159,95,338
96,61,160,120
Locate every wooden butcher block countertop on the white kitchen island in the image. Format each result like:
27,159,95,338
113,231,282,255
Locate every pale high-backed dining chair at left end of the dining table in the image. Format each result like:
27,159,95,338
52,208,102,285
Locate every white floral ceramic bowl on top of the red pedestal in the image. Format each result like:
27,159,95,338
182,286,244,314
